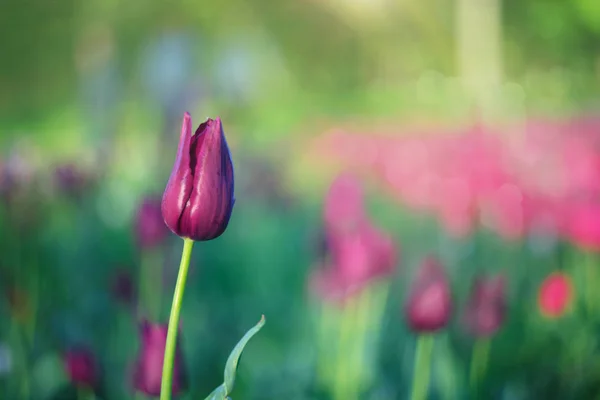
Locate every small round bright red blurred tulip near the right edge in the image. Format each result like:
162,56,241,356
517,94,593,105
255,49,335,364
538,272,573,318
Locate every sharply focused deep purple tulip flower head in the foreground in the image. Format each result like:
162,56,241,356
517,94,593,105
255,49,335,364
162,113,235,241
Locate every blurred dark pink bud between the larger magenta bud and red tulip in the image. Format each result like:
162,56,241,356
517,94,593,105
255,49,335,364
464,275,506,337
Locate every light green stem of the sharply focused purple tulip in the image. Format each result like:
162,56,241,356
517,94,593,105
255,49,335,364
160,239,194,400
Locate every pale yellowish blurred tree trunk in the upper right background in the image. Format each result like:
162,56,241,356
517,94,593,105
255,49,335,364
456,0,502,111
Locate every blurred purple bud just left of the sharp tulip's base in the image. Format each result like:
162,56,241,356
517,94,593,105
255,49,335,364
135,198,169,249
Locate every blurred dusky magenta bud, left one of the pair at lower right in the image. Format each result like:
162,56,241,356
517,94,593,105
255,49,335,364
405,257,452,333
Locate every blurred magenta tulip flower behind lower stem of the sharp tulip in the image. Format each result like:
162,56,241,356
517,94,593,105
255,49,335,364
133,320,187,396
